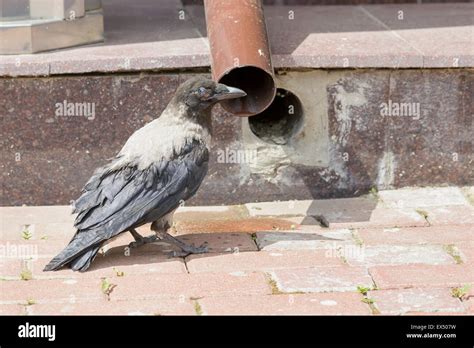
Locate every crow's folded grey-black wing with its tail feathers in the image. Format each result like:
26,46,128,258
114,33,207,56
46,140,209,270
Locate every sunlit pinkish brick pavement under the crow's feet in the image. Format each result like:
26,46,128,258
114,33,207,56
0,187,474,315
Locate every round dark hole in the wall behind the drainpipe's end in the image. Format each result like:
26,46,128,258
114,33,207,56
249,88,303,145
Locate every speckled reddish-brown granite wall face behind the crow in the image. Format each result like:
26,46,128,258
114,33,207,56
0,69,474,206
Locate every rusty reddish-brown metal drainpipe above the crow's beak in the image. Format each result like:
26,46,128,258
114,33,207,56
204,0,276,117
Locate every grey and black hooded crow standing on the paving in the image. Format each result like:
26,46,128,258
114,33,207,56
44,77,246,272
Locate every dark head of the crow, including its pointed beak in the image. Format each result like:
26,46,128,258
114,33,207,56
176,76,247,111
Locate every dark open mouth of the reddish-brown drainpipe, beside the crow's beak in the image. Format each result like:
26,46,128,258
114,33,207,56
219,66,275,116
